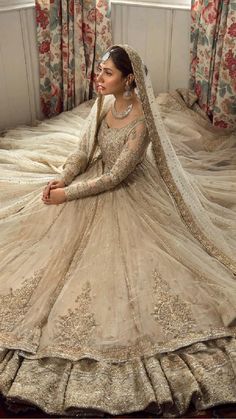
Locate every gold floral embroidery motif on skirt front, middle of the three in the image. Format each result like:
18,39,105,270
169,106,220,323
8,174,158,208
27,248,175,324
54,282,96,347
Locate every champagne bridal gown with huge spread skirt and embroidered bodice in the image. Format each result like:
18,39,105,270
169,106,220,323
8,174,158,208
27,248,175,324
0,92,236,416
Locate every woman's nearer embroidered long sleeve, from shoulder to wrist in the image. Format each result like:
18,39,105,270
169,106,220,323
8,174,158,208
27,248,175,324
64,122,148,201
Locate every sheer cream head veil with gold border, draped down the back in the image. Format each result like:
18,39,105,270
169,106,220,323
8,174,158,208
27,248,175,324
92,45,236,273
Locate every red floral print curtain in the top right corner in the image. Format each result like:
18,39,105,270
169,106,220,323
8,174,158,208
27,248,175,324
190,0,236,128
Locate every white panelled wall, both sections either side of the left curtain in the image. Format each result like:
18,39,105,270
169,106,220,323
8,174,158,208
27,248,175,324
0,3,190,130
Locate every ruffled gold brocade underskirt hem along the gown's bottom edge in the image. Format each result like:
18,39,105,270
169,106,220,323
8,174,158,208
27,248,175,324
0,339,236,417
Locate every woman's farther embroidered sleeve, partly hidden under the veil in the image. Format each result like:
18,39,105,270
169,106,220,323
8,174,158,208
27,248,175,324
61,134,87,185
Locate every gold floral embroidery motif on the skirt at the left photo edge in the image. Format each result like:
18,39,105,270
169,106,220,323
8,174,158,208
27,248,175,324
0,269,44,332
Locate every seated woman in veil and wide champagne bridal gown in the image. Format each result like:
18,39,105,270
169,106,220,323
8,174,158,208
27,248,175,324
0,46,236,416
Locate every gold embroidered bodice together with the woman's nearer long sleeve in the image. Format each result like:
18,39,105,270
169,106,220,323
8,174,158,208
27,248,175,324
64,117,149,201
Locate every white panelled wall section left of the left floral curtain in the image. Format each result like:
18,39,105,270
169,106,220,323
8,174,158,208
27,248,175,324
0,3,41,130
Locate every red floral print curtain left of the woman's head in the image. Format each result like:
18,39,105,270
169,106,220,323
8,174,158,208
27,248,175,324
36,0,112,117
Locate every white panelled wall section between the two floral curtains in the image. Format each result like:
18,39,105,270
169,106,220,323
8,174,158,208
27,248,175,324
112,4,190,93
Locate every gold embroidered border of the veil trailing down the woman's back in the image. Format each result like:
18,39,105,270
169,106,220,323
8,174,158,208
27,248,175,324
122,45,236,273
